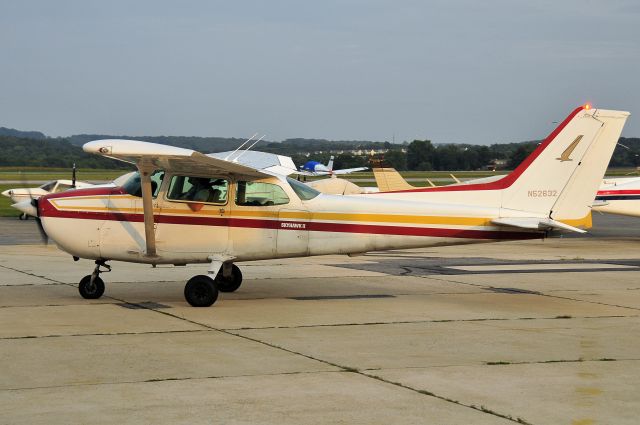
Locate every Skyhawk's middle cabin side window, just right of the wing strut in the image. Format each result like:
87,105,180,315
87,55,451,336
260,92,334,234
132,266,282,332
167,176,229,204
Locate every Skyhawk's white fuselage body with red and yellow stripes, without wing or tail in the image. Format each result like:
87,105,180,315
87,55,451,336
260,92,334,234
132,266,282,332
39,175,545,264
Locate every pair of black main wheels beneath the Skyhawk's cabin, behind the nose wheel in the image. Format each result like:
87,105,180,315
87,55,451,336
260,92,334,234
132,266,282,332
184,264,242,307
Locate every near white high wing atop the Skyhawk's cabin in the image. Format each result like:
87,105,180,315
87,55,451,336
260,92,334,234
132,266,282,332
82,139,270,177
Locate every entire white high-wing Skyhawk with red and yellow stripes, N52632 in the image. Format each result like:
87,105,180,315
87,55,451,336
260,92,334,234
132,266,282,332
22,107,629,307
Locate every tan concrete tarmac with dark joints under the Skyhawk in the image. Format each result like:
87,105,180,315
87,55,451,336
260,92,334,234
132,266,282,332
0,216,640,425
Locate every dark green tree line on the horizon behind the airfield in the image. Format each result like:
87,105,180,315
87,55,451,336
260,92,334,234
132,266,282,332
0,135,640,171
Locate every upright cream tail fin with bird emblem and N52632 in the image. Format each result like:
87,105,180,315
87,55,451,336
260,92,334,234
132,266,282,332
500,106,629,225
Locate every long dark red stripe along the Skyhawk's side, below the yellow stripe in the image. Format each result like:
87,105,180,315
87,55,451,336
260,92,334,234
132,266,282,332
40,208,543,239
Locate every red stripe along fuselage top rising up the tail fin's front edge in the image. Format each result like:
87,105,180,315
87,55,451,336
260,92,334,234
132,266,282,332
372,106,584,195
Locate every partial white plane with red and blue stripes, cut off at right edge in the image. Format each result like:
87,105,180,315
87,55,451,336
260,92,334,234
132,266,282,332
593,177,640,217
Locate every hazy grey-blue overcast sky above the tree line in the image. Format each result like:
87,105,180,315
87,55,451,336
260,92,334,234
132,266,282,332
0,0,640,143
